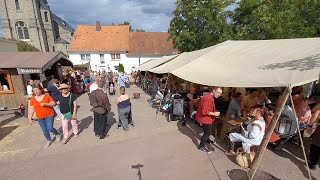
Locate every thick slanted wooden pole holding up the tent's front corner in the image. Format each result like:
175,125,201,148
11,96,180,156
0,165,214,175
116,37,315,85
249,86,291,180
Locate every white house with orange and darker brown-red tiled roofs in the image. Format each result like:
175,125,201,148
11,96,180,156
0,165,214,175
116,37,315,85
68,22,178,73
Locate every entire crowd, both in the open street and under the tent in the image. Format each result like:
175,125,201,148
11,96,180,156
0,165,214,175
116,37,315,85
27,68,320,168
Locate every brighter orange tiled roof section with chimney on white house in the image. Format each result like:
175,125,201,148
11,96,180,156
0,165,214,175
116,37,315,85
68,25,130,52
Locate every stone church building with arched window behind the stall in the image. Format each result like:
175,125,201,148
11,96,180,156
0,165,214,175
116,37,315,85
0,0,74,54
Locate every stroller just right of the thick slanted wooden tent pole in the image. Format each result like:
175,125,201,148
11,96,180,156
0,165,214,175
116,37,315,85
275,105,299,150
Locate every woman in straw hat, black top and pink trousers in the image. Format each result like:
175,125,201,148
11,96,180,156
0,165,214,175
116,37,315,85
57,84,79,144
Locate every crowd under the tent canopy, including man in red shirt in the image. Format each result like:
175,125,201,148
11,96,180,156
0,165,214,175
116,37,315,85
135,72,320,169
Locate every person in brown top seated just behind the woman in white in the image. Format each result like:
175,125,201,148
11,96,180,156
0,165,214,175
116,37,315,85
241,89,260,118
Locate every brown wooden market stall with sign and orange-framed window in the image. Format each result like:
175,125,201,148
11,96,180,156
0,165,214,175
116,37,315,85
0,52,72,107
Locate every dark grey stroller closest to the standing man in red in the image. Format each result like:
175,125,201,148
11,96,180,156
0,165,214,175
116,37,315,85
168,94,187,125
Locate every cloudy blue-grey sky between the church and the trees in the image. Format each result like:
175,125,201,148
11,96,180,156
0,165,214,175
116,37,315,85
48,0,176,32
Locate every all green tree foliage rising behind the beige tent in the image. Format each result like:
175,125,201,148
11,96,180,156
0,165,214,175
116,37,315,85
168,0,320,52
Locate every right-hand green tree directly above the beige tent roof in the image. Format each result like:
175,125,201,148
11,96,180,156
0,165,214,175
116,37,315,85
232,0,320,39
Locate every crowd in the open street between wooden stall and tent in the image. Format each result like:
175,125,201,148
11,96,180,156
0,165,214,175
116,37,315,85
26,68,131,147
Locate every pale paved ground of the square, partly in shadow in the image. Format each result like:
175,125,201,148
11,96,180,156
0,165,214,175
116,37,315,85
0,86,320,180
